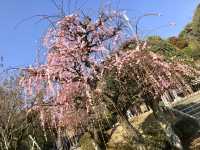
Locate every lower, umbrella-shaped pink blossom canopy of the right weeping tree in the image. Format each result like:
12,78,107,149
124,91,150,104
104,43,200,100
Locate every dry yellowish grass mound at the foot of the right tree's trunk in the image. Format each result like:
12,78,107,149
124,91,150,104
107,112,166,150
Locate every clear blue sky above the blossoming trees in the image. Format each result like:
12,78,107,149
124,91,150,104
0,0,200,67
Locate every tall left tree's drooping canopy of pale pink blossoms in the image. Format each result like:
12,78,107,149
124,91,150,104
21,11,125,127
